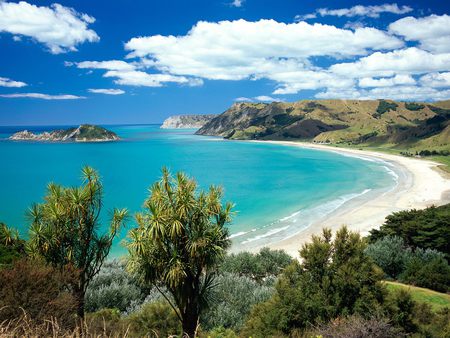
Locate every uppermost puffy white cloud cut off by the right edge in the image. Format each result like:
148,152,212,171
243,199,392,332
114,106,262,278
389,14,450,53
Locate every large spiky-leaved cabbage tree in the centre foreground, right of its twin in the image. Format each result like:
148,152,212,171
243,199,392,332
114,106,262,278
127,169,232,336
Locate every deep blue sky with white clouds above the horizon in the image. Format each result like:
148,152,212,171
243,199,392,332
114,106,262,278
0,0,450,126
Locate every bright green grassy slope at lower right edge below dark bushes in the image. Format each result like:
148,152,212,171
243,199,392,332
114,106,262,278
385,281,450,311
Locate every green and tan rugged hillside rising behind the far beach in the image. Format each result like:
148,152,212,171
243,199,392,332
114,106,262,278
197,100,450,151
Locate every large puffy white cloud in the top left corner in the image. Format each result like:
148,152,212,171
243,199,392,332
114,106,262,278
0,1,100,54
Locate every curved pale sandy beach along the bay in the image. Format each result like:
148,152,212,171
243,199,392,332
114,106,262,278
252,141,450,257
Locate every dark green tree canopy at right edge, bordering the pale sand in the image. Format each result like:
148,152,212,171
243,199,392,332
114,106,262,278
369,204,450,260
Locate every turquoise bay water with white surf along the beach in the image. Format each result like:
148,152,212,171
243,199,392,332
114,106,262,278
0,125,395,255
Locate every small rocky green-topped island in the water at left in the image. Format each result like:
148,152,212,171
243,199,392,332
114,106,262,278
9,124,120,142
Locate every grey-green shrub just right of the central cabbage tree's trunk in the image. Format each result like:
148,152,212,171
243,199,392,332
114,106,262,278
201,273,274,331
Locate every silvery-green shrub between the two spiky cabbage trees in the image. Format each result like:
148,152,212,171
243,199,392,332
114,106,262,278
86,261,143,312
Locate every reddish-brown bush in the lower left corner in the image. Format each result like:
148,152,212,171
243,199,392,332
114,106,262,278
0,259,76,327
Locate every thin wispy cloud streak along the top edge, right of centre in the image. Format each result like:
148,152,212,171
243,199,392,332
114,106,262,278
296,3,413,20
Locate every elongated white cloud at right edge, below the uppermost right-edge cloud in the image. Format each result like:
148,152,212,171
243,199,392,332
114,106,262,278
329,47,450,78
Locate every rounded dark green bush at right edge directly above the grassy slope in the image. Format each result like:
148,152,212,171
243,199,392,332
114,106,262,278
399,248,450,292
